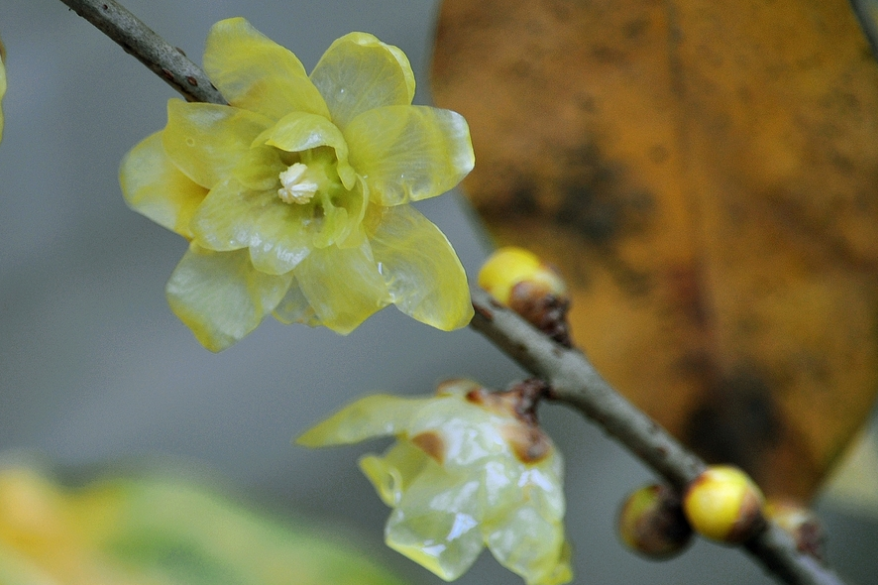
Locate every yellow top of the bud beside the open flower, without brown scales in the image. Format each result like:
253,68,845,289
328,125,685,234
479,246,567,306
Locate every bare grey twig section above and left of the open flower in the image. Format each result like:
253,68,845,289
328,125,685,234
61,0,226,104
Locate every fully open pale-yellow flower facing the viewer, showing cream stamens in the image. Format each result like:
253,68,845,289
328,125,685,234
121,18,473,351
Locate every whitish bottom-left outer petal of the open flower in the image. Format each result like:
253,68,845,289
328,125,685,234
165,244,292,351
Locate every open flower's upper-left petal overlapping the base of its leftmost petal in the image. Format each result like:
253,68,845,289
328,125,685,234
162,99,271,189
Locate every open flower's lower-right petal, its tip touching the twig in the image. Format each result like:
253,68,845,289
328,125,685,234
368,205,473,331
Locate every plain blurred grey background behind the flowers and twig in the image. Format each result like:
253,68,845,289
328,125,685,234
0,0,878,585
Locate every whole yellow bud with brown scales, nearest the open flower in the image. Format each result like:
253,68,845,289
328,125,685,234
479,246,570,347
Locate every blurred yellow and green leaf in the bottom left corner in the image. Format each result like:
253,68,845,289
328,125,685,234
0,467,403,585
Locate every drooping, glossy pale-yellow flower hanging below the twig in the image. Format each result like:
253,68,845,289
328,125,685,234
298,380,572,585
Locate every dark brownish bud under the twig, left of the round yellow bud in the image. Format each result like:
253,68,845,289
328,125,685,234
619,484,692,560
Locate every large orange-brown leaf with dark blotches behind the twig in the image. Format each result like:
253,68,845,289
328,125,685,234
433,0,878,498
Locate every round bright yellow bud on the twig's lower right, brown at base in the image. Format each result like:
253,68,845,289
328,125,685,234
683,465,765,544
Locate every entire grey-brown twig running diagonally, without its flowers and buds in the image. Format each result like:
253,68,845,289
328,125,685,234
61,0,843,585
